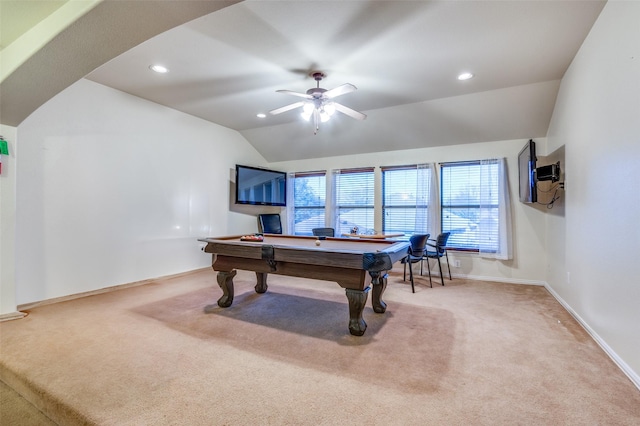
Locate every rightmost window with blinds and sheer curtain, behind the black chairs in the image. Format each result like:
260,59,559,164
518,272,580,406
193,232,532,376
440,159,511,259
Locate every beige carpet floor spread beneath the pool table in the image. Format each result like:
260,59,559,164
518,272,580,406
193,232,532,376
0,269,640,425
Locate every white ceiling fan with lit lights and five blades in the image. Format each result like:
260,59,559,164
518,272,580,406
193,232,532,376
269,71,367,135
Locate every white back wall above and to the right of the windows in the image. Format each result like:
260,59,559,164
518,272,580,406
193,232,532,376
269,138,547,284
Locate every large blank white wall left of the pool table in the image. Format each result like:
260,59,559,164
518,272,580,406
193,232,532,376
15,80,265,305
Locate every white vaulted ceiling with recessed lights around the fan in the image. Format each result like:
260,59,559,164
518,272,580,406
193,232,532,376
2,0,604,162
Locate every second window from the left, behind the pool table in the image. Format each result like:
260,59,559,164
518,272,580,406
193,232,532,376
334,167,374,235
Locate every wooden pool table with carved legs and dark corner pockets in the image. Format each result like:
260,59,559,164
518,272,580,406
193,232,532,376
199,234,409,336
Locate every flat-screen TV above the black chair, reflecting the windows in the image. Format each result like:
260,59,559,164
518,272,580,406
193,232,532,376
236,164,287,206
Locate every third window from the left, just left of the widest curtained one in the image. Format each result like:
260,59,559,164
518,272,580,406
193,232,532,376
382,165,436,237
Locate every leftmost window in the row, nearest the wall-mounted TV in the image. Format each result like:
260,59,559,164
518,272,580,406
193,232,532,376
291,171,327,235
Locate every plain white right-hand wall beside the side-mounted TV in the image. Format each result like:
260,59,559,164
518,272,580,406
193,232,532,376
548,0,640,386
